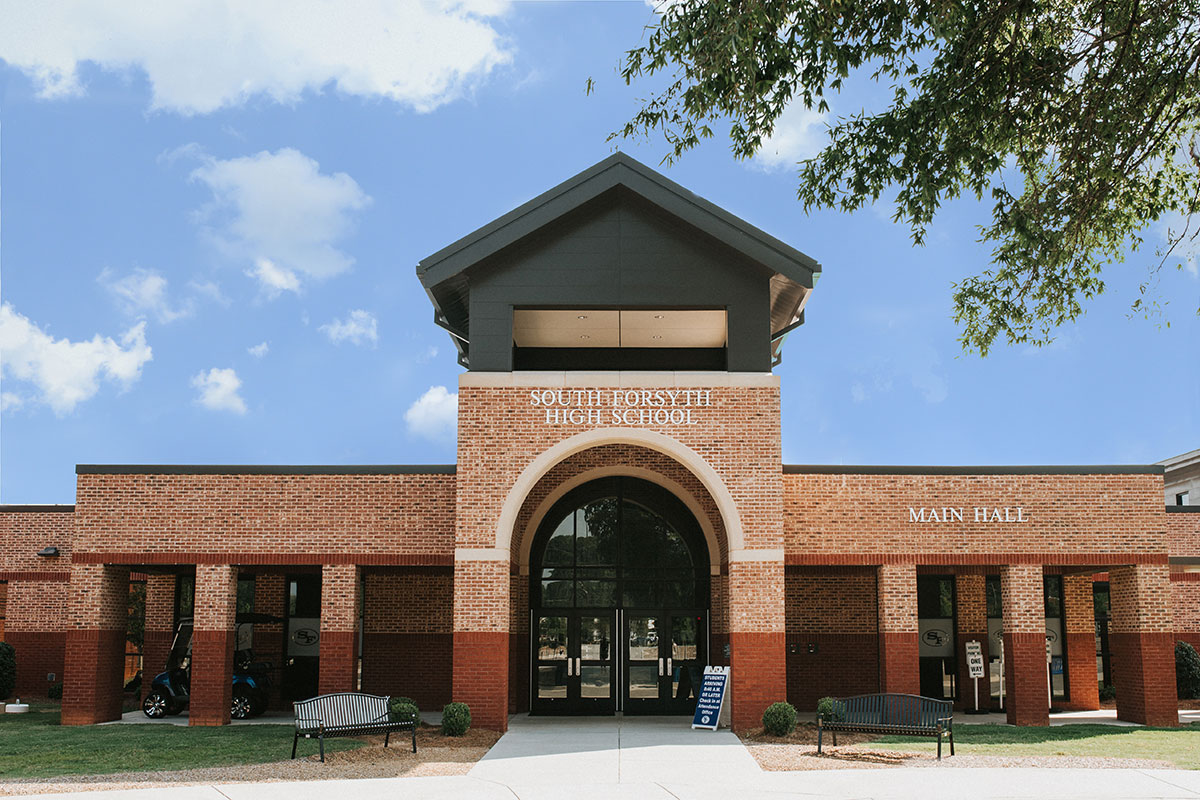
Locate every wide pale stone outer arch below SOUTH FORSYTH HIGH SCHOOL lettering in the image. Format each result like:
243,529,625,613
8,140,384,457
496,428,745,564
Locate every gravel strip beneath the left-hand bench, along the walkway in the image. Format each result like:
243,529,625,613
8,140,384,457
0,729,500,795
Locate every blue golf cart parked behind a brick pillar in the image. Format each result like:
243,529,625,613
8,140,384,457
142,612,283,720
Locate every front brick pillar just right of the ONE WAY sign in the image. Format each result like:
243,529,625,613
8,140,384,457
1000,564,1050,726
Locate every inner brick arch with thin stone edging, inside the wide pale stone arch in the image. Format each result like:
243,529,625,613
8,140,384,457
512,453,728,575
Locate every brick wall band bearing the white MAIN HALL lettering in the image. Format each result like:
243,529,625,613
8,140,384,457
784,474,1166,565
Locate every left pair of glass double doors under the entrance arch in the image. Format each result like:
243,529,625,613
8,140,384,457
532,610,617,714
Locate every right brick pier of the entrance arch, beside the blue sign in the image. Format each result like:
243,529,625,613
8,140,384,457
728,549,787,732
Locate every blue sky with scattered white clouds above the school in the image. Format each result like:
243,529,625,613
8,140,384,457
0,0,1200,503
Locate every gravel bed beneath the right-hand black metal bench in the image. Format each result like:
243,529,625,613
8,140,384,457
742,724,1178,771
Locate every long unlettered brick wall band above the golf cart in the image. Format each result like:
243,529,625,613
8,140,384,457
76,473,455,565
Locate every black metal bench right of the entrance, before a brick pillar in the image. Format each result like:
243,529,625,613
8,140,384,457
817,694,954,760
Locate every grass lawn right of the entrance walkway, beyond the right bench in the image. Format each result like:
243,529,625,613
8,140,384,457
872,723,1200,770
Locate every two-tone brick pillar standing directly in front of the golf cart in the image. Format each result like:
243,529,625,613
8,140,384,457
187,564,238,726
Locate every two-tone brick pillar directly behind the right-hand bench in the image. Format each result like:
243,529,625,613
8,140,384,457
875,564,920,694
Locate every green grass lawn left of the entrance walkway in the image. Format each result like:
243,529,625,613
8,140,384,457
0,705,364,782
